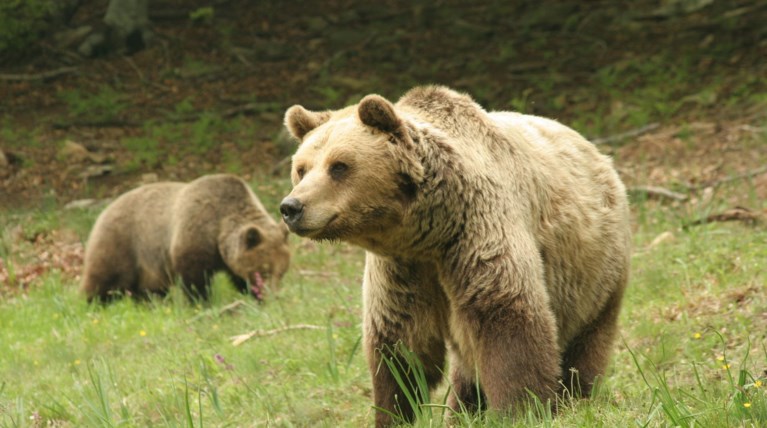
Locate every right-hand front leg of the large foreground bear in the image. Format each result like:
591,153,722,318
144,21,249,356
440,229,561,412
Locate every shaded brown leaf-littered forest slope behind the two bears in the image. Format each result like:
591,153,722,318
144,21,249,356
0,0,767,288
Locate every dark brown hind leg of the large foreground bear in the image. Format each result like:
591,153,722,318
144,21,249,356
562,291,623,397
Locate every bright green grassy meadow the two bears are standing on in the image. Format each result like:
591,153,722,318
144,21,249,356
0,178,767,427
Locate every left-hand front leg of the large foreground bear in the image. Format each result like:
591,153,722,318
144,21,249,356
363,253,448,427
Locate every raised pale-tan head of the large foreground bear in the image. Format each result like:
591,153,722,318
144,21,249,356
280,95,423,250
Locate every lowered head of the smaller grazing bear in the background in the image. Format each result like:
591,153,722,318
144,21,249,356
219,220,290,300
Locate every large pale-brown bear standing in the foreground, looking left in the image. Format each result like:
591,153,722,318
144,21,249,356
280,86,630,426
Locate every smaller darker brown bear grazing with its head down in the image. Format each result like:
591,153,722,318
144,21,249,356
82,174,290,301
